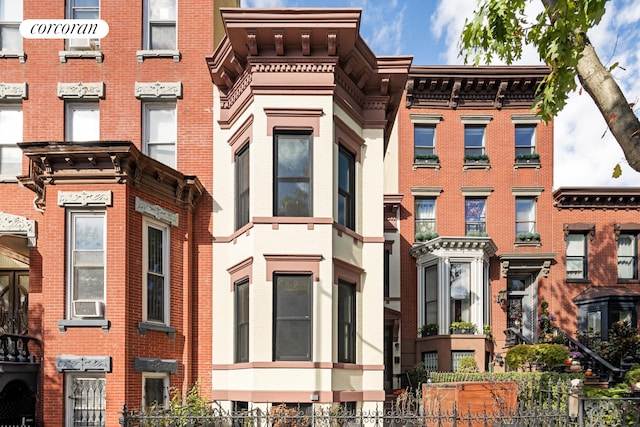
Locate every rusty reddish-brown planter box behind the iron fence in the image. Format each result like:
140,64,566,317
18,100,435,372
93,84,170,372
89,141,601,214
422,381,518,426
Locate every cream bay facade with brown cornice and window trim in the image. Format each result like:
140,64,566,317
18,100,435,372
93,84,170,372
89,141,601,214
207,9,411,408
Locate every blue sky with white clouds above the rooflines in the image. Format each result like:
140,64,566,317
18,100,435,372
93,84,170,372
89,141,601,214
241,0,640,188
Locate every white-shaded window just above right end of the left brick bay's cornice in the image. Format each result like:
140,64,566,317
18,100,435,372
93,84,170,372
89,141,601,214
143,102,178,168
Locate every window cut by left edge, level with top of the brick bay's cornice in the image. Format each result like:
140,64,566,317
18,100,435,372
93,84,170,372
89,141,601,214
0,105,22,180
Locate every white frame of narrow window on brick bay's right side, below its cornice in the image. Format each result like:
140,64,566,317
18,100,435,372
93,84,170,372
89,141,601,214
142,218,171,326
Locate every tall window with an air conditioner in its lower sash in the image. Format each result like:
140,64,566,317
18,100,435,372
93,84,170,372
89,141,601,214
68,211,106,319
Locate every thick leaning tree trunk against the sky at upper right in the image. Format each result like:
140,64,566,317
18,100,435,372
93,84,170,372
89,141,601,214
576,40,640,172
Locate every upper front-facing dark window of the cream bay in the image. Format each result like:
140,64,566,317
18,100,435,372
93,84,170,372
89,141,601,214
273,132,312,216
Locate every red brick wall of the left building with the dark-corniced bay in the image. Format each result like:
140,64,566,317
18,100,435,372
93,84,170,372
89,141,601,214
0,0,213,425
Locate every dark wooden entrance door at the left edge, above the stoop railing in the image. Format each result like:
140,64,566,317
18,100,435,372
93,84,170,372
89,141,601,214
0,270,29,335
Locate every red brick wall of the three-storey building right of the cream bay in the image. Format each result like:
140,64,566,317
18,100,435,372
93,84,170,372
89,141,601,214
398,100,553,370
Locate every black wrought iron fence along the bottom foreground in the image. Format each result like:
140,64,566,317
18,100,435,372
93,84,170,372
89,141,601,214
120,390,640,427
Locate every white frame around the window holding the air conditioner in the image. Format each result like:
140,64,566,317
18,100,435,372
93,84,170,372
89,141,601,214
66,209,107,322
